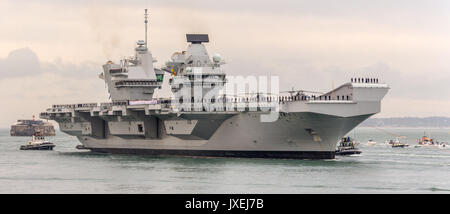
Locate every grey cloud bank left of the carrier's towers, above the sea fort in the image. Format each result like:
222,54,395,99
0,48,108,127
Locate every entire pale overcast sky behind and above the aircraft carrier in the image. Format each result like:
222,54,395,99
0,0,450,127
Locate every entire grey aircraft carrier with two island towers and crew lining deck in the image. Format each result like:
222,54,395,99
40,9,389,159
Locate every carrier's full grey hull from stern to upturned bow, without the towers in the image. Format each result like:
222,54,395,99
41,83,389,159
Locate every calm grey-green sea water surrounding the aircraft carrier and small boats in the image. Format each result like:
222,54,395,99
0,128,450,193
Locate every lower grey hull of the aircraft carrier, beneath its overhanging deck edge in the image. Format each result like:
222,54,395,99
77,112,372,159
